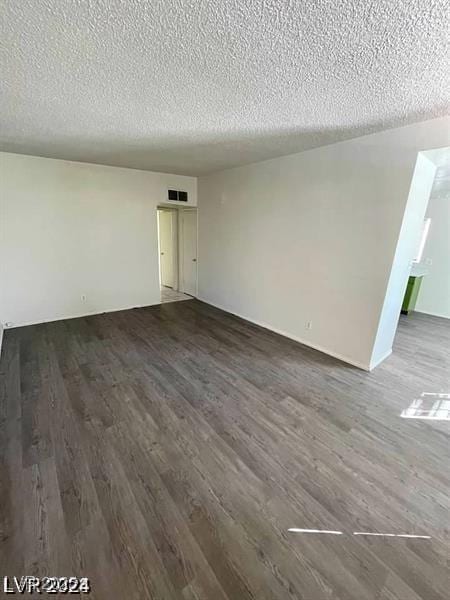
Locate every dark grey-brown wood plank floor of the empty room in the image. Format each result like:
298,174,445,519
0,300,450,600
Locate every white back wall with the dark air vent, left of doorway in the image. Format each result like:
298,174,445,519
0,153,197,326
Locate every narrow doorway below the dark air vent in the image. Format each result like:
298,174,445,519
157,206,197,303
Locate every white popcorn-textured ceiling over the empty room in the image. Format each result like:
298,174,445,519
0,0,450,175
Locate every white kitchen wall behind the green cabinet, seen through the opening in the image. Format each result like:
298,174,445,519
415,197,450,319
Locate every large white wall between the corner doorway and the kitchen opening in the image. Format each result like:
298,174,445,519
199,119,450,368
